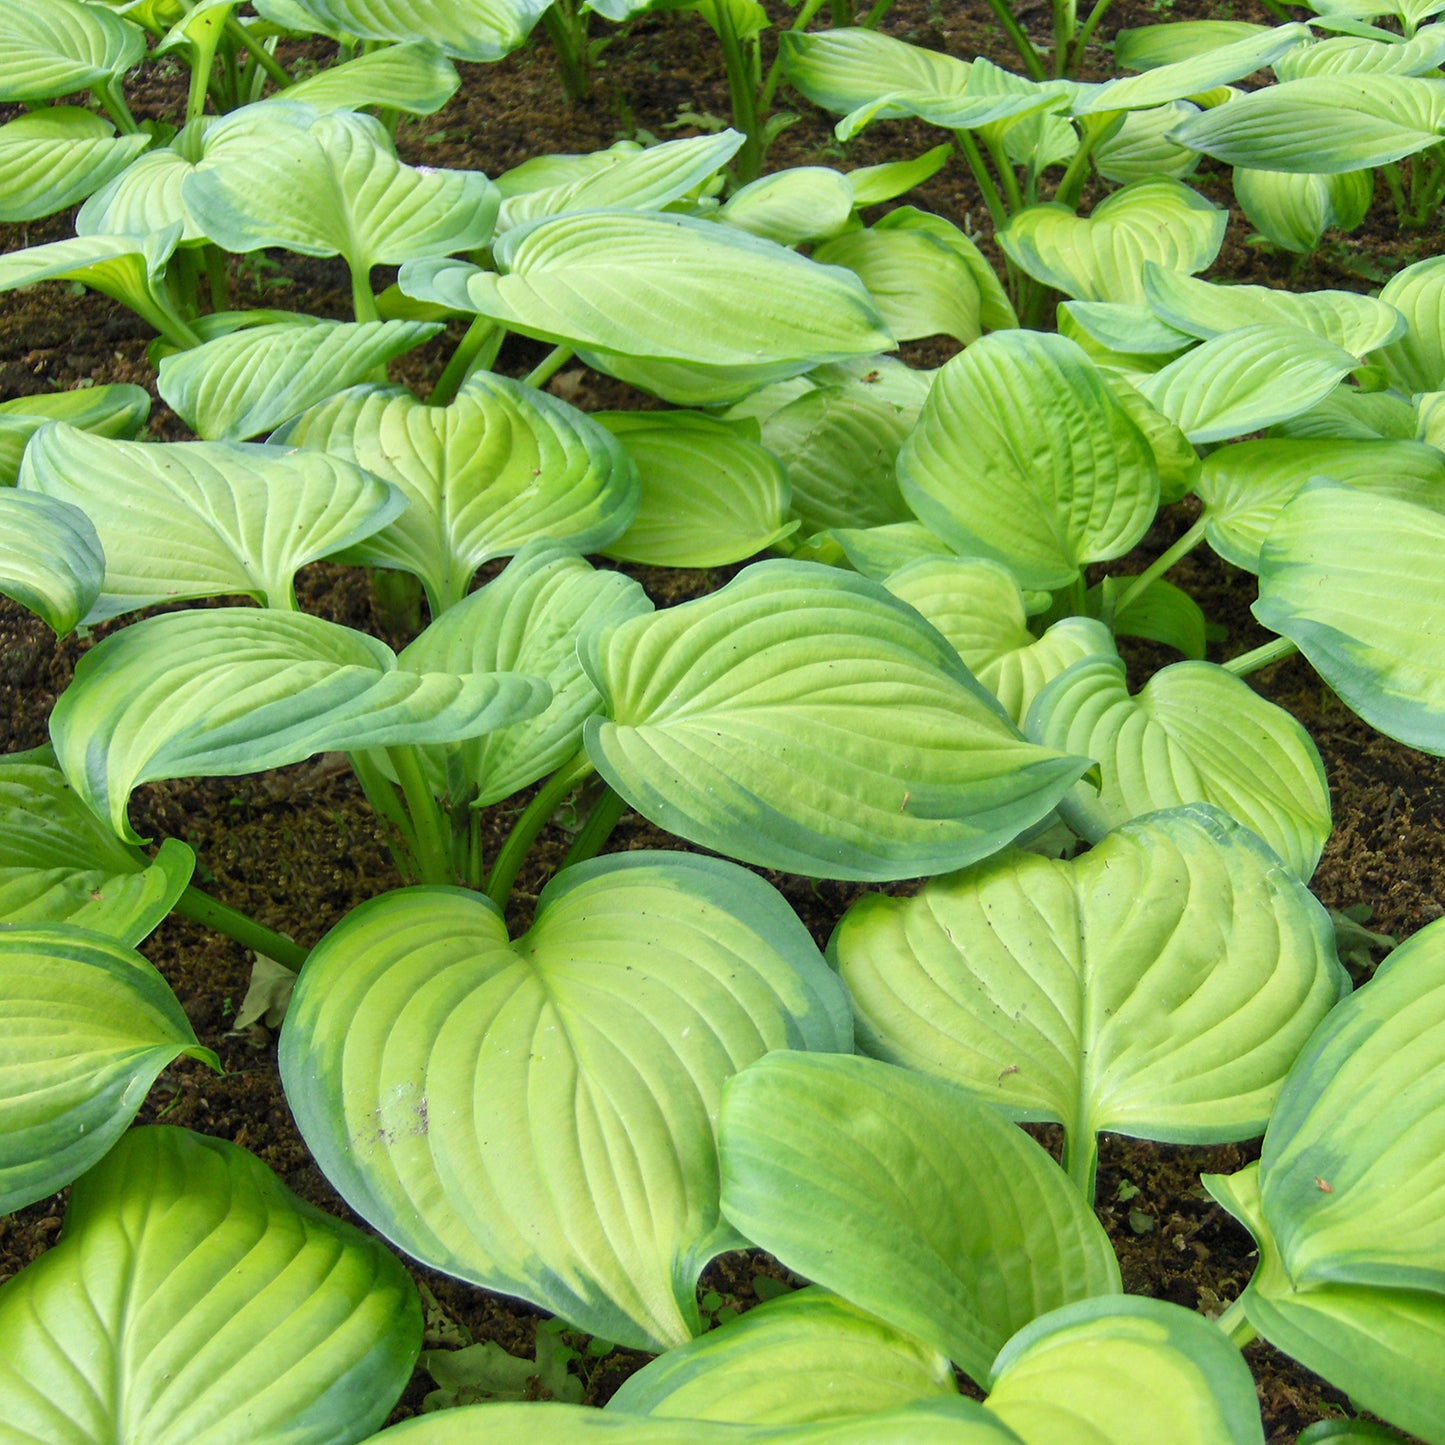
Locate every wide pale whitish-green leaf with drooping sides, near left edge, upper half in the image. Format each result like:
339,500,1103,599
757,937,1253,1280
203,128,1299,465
20,422,403,621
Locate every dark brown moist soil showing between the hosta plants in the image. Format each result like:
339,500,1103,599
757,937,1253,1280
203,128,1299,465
0,0,1445,1445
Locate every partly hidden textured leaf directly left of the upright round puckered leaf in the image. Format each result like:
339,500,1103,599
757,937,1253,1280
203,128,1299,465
763,384,919,532
